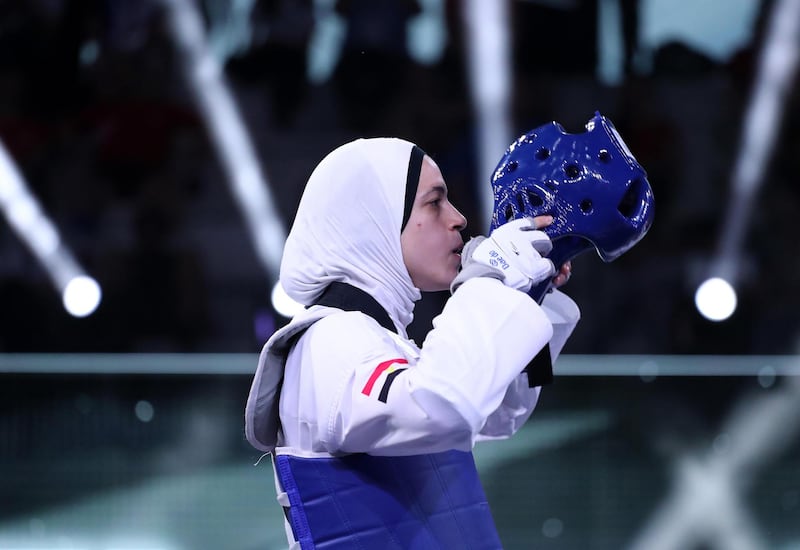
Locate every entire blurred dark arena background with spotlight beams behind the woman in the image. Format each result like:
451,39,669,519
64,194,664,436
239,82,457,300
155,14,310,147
0,0,800,550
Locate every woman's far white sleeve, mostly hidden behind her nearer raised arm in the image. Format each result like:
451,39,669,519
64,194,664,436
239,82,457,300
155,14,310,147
477,290,580,441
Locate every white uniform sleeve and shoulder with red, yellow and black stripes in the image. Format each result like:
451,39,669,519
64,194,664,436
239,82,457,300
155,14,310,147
280,278,553,455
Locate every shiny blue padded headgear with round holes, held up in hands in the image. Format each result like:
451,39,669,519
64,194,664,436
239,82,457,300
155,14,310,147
491,113,654,302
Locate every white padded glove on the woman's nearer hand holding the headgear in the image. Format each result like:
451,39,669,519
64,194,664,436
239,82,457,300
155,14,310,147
450,218,556,292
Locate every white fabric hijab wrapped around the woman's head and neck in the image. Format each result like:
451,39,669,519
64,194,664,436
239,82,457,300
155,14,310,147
280,138,421,336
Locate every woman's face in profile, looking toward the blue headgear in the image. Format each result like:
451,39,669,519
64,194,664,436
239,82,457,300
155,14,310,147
400,156,467,292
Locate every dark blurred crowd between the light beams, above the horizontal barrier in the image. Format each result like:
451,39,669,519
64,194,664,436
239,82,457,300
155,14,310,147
0,0,800,354
